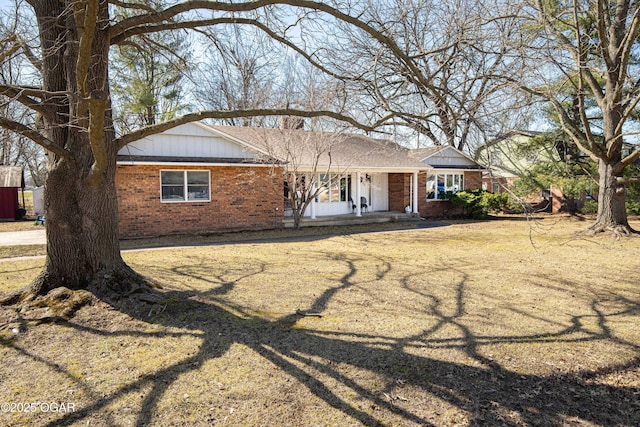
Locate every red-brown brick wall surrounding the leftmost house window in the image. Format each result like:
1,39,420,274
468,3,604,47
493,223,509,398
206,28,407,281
116,165,284,237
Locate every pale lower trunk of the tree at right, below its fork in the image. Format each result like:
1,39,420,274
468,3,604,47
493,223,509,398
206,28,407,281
589,159,633,235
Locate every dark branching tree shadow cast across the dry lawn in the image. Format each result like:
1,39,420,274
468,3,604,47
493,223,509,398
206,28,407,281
2,256,640,427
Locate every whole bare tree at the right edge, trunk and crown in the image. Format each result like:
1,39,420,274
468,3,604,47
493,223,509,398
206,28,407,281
522,0,640,234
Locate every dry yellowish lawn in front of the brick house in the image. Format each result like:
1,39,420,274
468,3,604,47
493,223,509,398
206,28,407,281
0,217,640,426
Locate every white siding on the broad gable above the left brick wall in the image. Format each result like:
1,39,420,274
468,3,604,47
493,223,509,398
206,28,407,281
118,124,257,159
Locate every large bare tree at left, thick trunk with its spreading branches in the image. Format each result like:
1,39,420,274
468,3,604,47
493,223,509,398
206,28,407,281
0,0,376,308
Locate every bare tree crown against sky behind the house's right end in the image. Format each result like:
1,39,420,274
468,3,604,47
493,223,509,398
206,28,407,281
284,0,526,150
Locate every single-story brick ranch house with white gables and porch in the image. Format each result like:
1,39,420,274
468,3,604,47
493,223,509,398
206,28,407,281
116,123,481,237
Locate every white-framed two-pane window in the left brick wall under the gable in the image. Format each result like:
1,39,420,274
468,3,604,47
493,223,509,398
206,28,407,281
160,171,211,202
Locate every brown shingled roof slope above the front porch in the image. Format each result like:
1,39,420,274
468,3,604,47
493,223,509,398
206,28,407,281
212,126,427,170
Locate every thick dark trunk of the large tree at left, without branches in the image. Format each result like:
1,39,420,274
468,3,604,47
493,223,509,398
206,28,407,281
5,0,151,308
